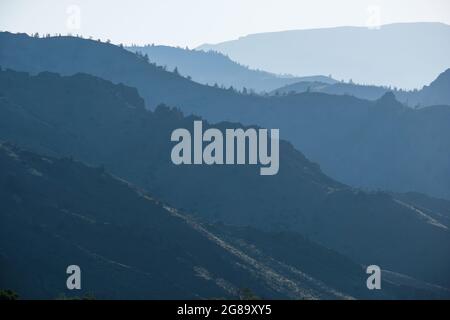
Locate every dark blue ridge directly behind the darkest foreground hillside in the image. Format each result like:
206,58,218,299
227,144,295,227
0,71,450,292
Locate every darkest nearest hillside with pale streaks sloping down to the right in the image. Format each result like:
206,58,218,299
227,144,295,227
5,143,444,299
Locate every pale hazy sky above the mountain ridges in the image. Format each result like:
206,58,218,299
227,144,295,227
0,0,450,48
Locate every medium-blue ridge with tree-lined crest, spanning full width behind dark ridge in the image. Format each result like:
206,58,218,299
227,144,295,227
0,33,450,199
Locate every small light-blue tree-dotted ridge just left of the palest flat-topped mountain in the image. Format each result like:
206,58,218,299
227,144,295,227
126,45,336,92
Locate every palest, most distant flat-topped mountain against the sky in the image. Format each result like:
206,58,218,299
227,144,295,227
197,22,450,89
